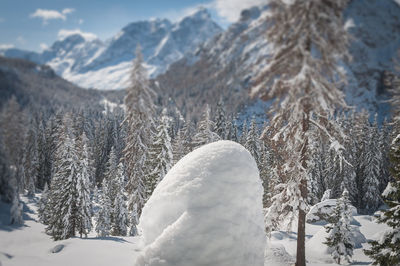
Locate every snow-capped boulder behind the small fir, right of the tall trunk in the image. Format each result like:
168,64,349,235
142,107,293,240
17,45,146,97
307,199,359,225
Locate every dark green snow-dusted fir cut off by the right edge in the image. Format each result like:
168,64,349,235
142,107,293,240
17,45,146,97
364,134,400,265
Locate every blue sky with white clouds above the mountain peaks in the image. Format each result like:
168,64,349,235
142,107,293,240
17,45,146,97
0,0,267,52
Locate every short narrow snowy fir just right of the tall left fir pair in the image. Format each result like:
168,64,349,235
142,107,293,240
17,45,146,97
95,178,112,237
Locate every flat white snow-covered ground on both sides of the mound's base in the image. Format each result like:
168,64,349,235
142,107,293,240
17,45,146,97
0,195,386,266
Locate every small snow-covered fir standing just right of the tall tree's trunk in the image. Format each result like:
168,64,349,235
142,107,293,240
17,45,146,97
325,190,354,264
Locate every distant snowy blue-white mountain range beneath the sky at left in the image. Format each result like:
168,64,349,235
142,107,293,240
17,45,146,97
0,9,222,90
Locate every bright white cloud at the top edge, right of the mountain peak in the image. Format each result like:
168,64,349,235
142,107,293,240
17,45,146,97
213,0,266,22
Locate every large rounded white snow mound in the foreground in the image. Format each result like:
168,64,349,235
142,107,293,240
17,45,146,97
135,141,266,266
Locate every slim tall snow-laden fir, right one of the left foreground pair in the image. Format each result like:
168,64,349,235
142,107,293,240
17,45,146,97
76,132,92,237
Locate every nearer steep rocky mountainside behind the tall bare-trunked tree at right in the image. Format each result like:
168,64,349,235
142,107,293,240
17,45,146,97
158,0,400,120
